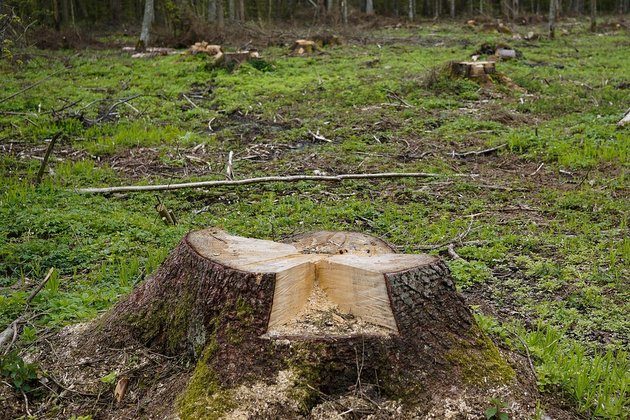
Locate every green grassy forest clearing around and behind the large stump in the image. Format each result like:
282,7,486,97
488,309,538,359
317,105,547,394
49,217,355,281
0,18,630,418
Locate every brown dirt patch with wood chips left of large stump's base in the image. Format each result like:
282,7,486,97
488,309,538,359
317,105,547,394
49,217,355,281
0,324,189,418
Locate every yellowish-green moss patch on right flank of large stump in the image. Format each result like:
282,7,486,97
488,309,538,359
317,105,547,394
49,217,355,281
446,326,516,384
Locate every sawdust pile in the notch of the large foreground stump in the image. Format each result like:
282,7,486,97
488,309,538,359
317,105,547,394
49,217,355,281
266,282,392,338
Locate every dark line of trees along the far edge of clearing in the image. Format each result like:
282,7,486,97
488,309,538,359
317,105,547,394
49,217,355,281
0,0,630,44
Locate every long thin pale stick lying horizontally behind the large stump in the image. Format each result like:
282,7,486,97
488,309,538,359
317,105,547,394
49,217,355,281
76,172,479,194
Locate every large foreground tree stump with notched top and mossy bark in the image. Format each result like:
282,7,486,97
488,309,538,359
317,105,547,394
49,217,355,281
95,229,514,418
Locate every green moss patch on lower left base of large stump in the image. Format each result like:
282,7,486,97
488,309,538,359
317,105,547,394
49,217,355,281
176,337,236,419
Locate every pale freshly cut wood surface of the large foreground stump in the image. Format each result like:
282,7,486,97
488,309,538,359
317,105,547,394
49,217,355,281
188,230,437,333
